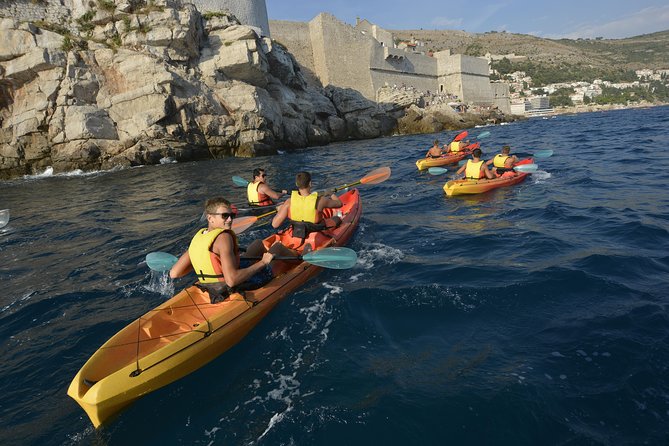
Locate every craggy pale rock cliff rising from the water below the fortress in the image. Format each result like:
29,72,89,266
0,0,512,179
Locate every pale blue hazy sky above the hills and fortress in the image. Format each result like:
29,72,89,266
266,0,669,39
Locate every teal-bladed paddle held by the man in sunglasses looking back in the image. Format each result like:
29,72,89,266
146,247,358,272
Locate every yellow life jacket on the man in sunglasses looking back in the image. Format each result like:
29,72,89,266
188,228,239,283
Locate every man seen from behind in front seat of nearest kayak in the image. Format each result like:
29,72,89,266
272,172,342,239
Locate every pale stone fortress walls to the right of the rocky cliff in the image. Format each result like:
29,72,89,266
270,13,510,113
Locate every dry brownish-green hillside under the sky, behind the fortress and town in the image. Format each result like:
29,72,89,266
391,30,669,70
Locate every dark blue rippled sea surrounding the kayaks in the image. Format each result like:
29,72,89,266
0,107,669,445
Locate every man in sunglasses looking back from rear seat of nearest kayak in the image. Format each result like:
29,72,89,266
170,197,292,303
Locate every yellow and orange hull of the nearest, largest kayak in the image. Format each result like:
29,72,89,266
67,189,362,428
